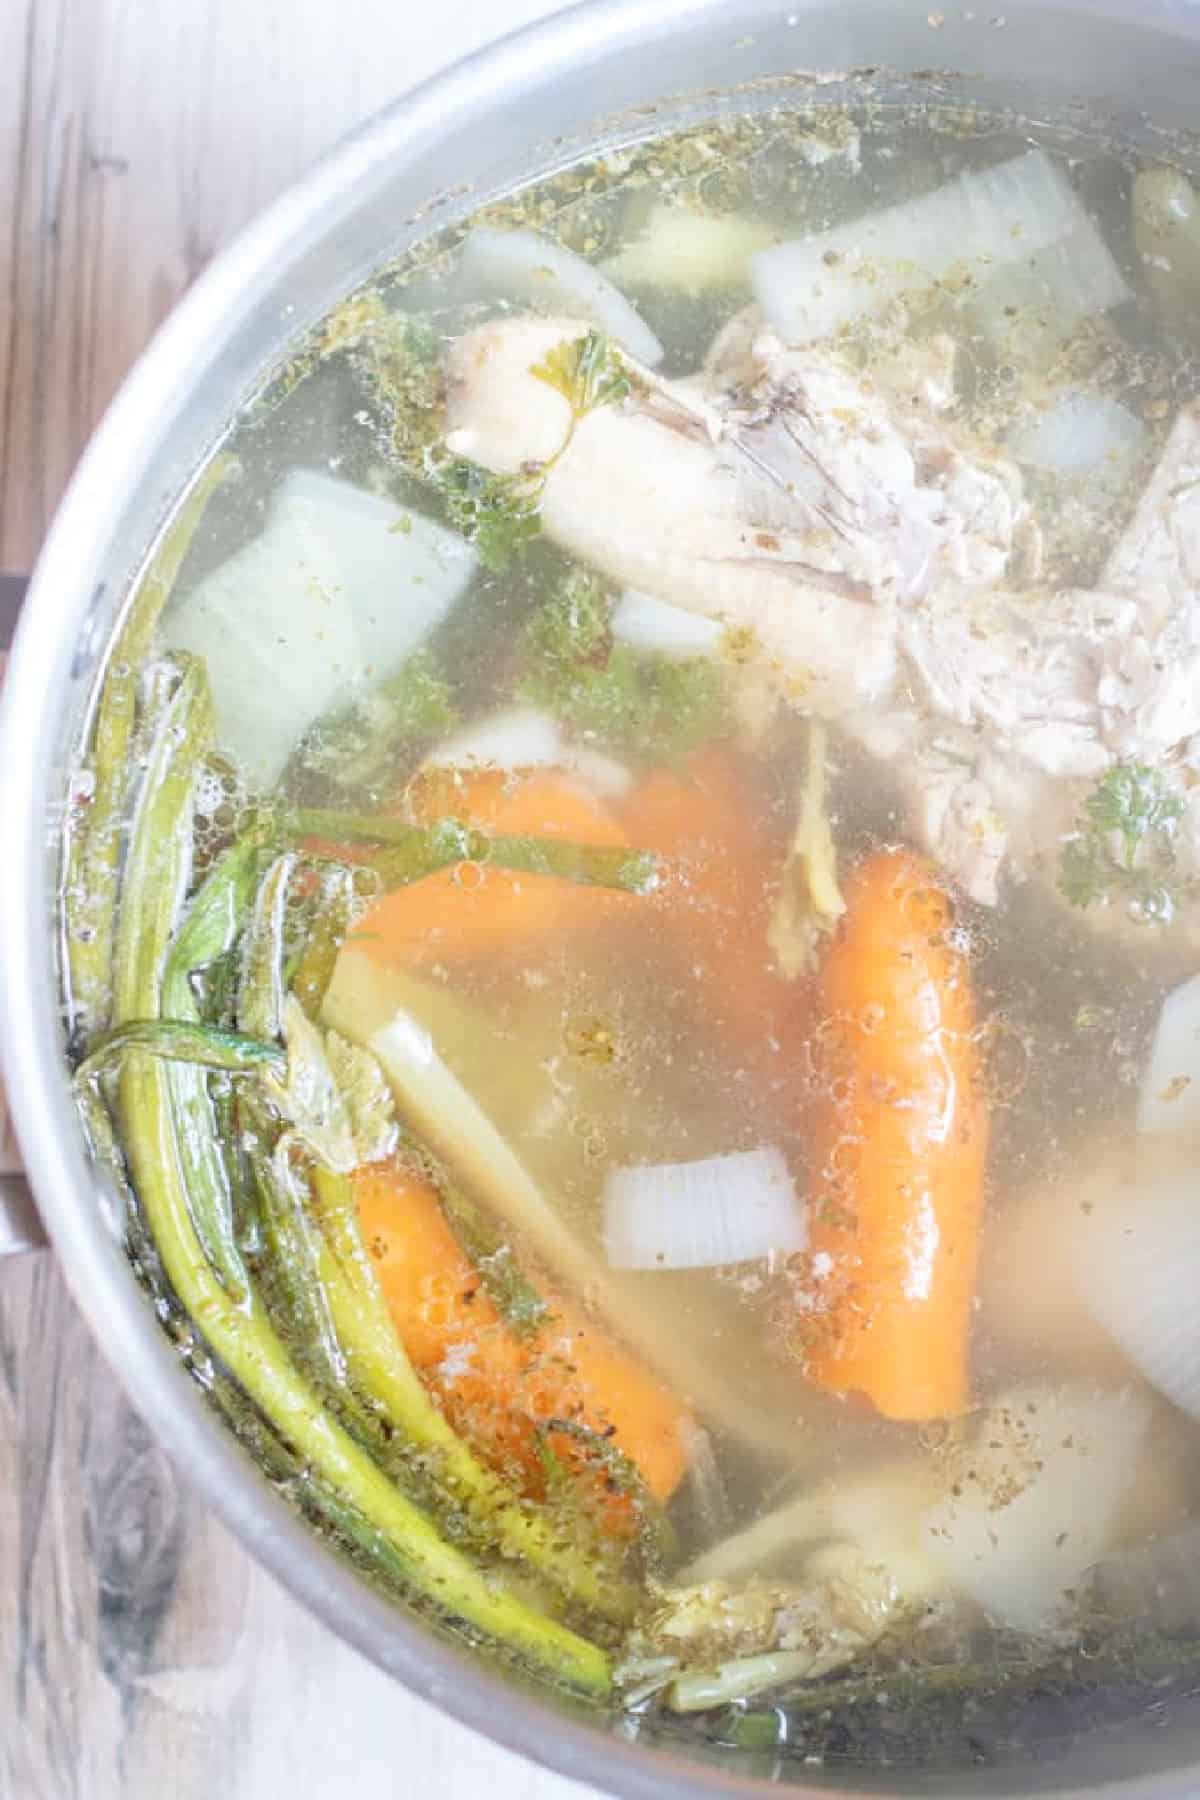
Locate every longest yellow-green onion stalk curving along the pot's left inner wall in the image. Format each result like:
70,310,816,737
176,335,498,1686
98,664,610,1699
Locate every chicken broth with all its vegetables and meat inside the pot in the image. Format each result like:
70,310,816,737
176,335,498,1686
63,106,1200,1768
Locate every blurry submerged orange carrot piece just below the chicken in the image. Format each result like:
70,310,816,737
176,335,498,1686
622,747,801,1055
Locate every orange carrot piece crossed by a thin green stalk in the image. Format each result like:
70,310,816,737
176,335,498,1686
354,769,639,965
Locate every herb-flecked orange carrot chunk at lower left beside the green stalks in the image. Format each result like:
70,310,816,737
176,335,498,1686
354,1165,685,1534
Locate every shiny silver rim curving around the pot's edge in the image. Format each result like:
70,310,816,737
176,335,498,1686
0,0,1200,1800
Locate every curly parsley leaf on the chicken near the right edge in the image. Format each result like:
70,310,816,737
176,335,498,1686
1058,763,1184,922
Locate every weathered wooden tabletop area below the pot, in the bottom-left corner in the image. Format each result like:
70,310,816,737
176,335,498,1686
0,1256,587,1800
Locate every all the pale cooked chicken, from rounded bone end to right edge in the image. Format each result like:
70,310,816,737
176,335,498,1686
440,311,1200,905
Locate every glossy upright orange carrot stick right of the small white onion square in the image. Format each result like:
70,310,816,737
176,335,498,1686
804,850,988,1420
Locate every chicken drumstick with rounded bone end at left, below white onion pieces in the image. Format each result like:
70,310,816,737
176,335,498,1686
446,319,1020,716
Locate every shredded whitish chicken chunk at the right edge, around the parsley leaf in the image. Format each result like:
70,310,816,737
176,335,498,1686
895,407,1200,907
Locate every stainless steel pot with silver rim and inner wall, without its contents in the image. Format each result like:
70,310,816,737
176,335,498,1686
0,0,1200,1800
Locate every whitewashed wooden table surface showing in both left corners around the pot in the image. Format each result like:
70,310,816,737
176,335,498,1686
0,0,597,1800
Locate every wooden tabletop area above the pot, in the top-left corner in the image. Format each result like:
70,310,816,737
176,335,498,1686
0,0,554,569
